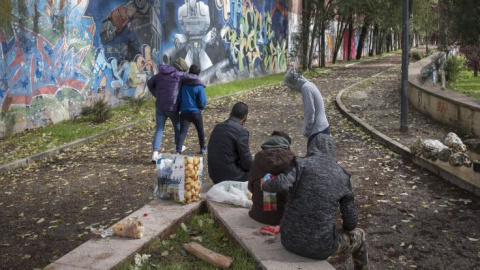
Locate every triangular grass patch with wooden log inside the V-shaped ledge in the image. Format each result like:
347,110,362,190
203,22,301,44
117,213,260,270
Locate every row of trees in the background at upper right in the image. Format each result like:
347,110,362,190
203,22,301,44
298,0,480,76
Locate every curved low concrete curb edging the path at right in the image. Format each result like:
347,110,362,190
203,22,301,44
335,69,480,196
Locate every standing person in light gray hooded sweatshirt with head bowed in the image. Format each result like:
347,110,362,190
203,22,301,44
283,68,330,147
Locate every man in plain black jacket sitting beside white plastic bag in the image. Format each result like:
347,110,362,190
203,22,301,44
208,102,252,184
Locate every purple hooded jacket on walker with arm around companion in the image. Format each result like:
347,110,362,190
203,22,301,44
147,65,203,112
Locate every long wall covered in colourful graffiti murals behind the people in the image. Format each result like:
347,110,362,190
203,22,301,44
0,0,288,138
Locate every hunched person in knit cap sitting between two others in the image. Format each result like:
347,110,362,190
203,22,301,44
248,131,295,225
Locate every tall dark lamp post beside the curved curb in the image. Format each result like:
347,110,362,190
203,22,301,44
400,0,410,132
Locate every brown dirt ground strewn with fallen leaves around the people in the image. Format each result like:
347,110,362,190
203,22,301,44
0,55,480,269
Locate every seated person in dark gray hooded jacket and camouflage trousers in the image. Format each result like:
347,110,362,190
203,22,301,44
261,134,368,270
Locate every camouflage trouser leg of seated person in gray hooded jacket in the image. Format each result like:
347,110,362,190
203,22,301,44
335,229,368,270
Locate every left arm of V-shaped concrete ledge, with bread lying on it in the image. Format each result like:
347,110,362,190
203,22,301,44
44,199,205,270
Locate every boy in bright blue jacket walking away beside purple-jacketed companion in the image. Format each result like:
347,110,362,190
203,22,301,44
176,65,207,154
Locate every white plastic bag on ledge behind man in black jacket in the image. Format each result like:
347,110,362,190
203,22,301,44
207,181,252,208
